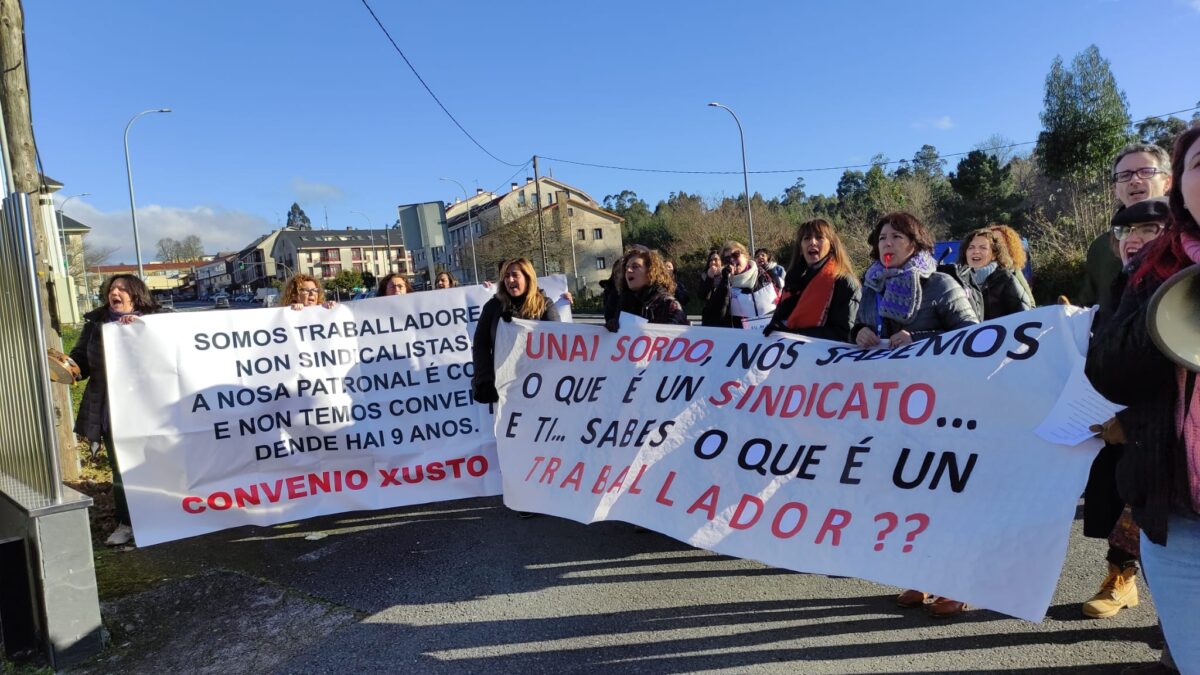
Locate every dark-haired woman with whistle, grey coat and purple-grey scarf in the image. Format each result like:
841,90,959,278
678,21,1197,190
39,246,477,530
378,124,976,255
852,213,979,617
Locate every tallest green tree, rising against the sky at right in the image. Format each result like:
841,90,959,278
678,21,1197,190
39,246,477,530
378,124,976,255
1036,44,1130,183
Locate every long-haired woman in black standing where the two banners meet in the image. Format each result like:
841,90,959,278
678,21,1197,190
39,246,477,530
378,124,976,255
470,258,558,404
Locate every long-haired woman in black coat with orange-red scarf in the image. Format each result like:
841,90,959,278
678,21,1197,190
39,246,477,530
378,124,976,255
763,219,860,342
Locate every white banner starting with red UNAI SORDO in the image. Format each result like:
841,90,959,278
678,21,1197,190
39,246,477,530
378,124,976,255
496,306,1111,621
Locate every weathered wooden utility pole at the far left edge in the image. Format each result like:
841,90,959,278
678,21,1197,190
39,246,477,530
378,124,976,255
0,0,79,480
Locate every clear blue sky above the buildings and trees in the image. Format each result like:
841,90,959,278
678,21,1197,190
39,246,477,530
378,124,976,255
25,0,1200,262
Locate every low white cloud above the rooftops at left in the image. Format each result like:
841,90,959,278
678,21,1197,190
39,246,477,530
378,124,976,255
67,201,276,264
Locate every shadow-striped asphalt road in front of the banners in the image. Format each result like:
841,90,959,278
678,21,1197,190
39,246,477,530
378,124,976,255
70,497,1162,675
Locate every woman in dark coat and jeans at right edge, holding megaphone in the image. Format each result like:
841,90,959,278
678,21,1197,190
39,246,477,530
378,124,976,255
1087,125,1200,673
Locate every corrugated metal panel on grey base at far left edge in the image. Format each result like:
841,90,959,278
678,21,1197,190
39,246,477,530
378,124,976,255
0,192,62,510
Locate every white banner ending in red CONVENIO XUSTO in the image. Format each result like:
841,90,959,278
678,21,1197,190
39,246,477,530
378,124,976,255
104,286,500,545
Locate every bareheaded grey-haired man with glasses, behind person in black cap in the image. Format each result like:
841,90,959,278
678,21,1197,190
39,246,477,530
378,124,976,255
1074,143,1171,309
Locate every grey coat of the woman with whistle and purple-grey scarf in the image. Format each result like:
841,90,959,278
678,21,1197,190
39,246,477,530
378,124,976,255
850,271,979,341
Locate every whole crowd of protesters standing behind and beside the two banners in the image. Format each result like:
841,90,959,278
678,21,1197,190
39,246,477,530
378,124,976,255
71,120,1200,673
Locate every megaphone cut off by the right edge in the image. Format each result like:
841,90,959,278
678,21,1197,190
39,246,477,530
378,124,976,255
1146,264,1200,372
